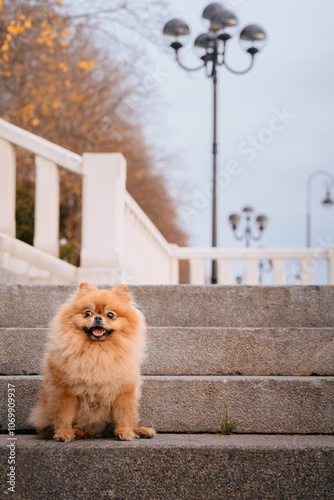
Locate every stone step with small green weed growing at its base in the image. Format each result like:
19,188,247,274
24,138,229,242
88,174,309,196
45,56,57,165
0,376,334,434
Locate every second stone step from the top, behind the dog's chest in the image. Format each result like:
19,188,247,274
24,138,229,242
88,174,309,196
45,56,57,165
0,327,334,376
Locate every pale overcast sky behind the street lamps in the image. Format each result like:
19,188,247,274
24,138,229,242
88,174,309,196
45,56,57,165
142,0,334,270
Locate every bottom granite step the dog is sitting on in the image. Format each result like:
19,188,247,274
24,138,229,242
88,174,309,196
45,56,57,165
0,434,334,500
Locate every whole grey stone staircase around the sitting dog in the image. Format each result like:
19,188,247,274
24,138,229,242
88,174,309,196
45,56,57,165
0,285,334,500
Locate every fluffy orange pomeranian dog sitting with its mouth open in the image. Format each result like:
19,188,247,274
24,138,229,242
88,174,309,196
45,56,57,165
29,283,155,442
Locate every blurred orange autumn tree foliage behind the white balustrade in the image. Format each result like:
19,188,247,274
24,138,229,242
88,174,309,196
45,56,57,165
0,0,187,264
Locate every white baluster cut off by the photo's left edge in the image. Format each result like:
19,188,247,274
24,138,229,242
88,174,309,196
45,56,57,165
0,139,16,238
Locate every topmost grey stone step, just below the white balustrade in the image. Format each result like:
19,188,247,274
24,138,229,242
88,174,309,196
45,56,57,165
0,285,334,328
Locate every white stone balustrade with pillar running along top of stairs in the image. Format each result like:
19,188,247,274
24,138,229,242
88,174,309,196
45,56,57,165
0,119,334,285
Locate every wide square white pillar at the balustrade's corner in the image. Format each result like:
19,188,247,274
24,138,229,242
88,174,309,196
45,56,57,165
80,153,126,276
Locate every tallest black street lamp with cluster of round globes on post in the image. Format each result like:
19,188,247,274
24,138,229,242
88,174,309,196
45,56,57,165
163,3,266,284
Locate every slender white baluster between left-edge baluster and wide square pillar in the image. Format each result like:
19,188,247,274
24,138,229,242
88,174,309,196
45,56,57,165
34,156,59,257
